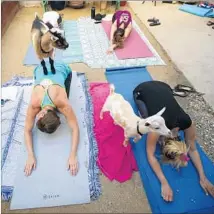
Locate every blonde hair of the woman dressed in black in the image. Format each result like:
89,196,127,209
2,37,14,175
161,139,189,169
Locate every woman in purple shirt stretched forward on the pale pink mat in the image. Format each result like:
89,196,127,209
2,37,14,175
107,10,132,54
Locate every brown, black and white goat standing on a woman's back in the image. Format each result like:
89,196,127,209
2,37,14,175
31,14,69,75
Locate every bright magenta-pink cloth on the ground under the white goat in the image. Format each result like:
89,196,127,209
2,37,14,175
90,83,137,182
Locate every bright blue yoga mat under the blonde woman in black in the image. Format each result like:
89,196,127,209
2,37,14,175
106,67,214,213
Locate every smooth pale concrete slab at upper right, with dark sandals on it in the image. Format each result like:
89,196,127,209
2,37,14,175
129,1,214,109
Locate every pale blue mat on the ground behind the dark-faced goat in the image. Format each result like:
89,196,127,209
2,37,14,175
23,21,83,66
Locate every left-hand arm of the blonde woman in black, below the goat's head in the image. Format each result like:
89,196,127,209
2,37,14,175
146,133,173,201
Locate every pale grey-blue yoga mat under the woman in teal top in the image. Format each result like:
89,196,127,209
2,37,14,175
10,66,91,210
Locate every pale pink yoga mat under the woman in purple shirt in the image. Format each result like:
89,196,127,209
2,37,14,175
102,21,154,59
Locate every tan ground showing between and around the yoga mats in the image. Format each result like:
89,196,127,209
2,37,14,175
2,0,214,213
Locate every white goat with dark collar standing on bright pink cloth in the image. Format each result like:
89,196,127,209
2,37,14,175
100,84,171,146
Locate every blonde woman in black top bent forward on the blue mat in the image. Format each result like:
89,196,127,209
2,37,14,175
133,81,214,201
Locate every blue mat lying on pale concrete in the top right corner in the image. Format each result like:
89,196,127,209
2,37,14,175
179,4,214,18
